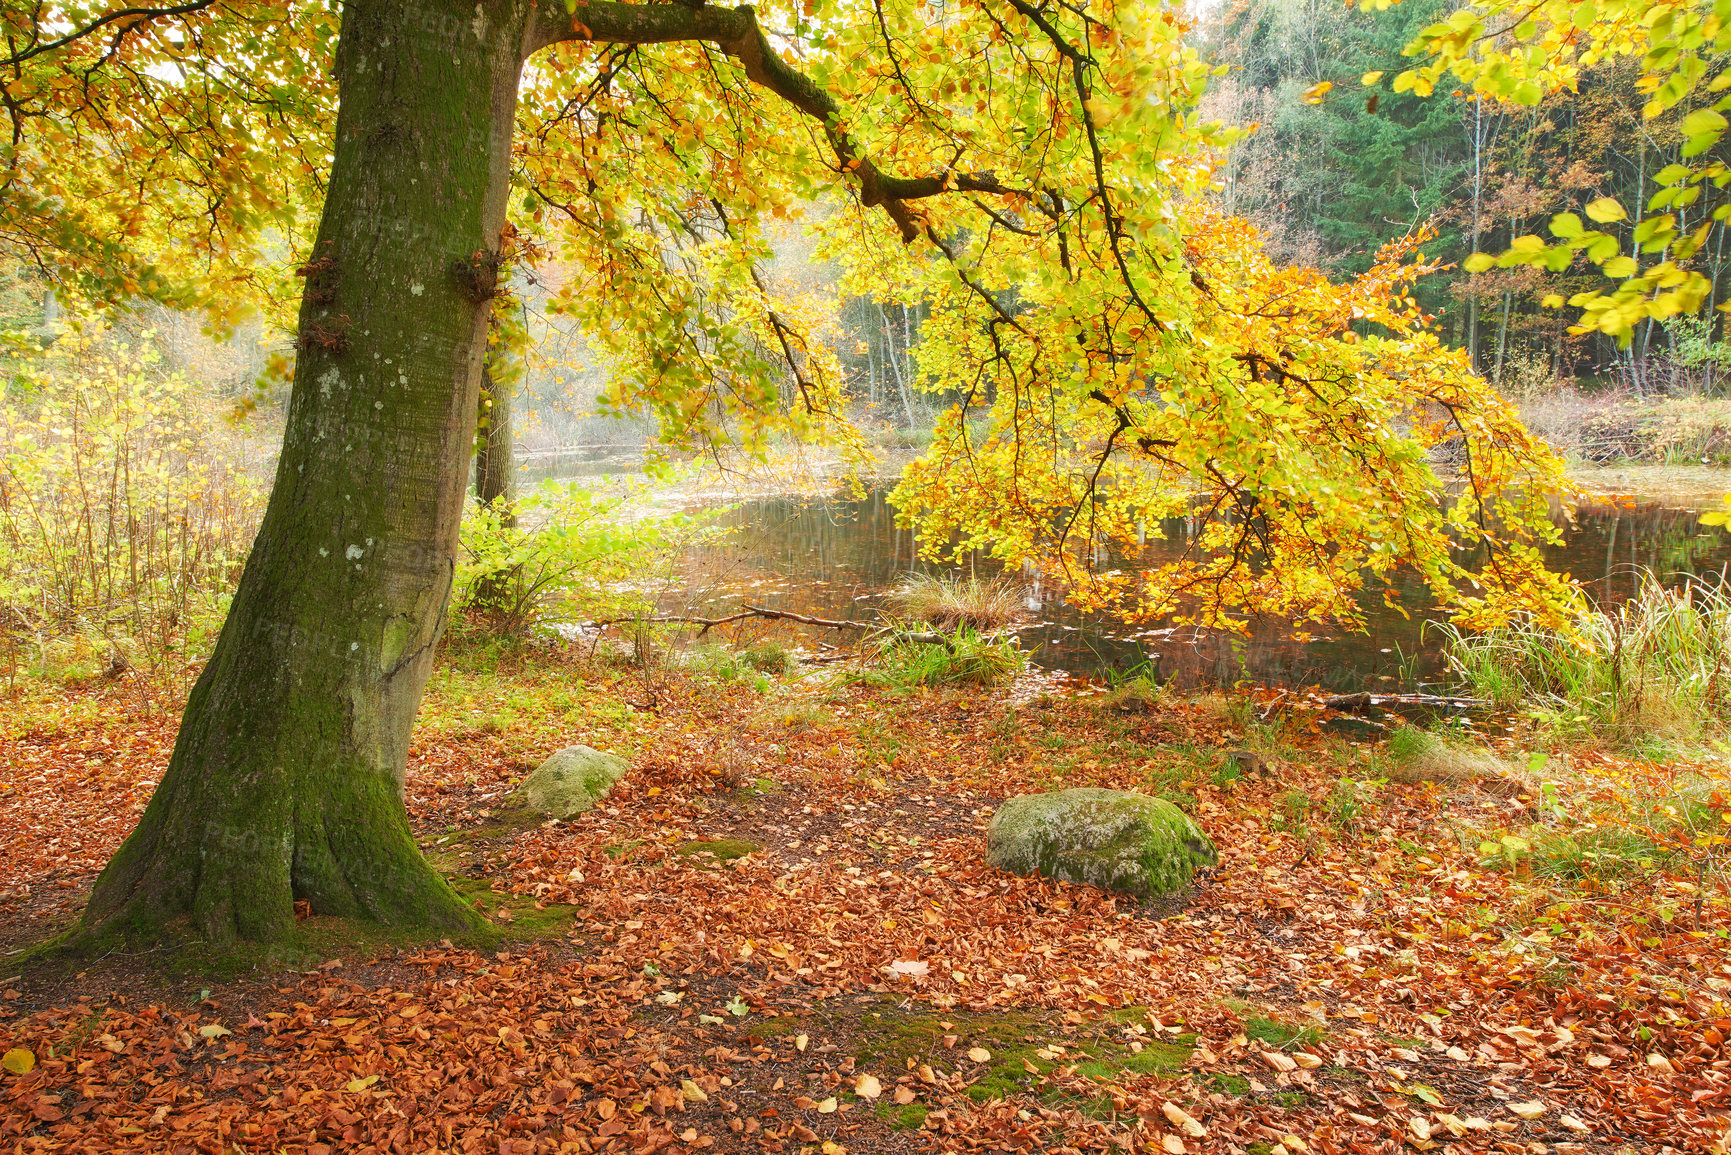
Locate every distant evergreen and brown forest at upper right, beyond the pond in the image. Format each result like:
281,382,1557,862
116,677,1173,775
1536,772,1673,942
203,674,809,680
1198,0,1731,406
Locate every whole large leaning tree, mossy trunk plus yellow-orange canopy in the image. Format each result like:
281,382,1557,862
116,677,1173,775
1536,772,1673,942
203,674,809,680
10,0,1675,939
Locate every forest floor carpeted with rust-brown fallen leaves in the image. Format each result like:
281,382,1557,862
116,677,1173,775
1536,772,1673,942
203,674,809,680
0,651,1731,1155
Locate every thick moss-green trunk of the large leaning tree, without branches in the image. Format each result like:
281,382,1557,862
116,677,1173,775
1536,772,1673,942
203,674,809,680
85,0,530,940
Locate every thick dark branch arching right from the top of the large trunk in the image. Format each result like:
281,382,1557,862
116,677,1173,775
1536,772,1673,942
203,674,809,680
528,0,1011,241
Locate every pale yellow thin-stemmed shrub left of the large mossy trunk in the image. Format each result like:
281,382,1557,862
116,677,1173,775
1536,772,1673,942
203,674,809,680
0,329,265,668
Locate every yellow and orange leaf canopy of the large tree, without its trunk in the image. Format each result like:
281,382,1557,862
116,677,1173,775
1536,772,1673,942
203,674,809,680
5,0,1585,640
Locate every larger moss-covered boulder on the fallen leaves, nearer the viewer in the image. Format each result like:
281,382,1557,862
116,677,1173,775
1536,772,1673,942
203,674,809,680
985,788,1219,899
